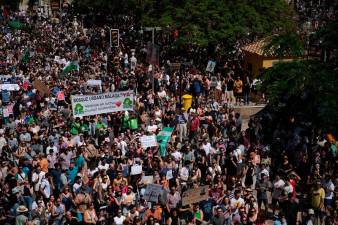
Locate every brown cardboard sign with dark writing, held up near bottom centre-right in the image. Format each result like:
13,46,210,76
182,186,209,206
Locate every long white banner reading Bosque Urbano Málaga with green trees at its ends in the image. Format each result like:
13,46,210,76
71,91,134,117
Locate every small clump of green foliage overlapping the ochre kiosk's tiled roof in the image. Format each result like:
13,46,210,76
264,33,304,57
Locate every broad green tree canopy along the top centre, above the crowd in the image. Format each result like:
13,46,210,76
76,0,296,46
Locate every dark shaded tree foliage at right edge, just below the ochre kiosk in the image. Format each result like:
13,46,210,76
261,61,338,129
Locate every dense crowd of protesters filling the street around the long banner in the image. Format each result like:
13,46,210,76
0,2,338,225
